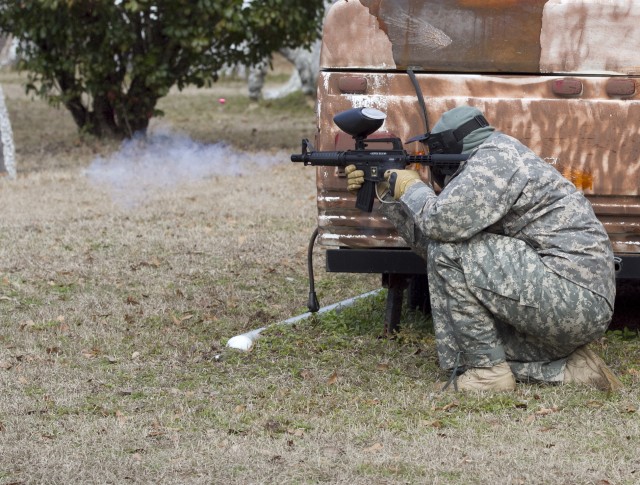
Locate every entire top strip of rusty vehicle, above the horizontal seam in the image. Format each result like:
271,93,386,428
320,0,640,75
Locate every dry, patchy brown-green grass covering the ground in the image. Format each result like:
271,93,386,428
0,65,640,484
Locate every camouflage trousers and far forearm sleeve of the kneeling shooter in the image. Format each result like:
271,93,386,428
384,201,612,382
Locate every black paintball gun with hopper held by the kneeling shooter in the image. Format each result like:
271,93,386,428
291,108,469,212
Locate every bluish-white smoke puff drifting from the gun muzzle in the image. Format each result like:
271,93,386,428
85,129,285,207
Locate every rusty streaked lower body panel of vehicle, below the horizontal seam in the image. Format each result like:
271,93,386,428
317,72,640,252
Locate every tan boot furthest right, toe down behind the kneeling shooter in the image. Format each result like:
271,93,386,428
563,345,623,391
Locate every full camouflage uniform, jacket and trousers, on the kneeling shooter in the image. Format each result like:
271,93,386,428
383,132,615,382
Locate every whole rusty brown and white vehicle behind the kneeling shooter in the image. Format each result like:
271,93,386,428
302,0,640,331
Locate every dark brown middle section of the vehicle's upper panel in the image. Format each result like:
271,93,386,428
360,0,545,72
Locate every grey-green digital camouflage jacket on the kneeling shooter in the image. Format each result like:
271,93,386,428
400,132,615,308
